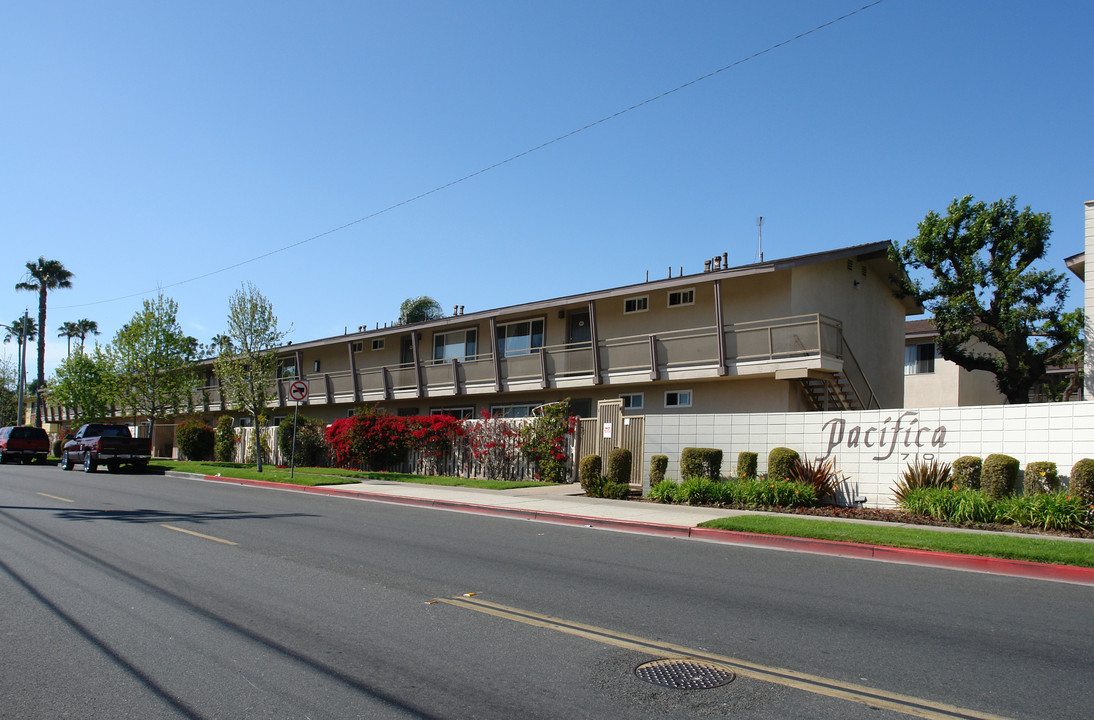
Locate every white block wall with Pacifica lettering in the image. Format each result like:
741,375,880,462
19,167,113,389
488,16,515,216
643,403,1094,508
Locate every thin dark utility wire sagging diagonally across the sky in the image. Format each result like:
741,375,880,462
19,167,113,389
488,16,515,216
58,0,884,310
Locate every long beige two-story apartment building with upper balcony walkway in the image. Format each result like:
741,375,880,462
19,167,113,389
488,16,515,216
175,242,919,420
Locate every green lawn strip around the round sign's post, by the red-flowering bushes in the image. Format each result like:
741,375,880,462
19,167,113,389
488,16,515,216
149,460,549,490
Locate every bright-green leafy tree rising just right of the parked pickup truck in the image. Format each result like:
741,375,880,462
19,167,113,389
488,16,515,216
108,293,196,437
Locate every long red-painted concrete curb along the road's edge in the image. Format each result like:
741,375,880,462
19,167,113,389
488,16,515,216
165,471,1094,585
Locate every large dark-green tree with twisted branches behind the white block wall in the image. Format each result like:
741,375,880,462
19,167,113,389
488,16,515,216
894,196,1076,404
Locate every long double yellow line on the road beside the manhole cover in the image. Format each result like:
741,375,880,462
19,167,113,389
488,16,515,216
435,595,1008,720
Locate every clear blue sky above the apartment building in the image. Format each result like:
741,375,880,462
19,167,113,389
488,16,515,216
0,0,1094,376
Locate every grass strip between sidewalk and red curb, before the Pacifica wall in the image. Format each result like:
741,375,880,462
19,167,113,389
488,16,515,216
699,515,1094,568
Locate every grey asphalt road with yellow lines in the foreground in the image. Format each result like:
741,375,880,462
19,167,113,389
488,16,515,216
0,465,1094,720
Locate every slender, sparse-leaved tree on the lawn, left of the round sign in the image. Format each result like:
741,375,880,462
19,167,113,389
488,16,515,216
213,282,288,473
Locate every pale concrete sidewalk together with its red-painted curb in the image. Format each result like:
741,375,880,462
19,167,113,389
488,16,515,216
166,471,1094,585
